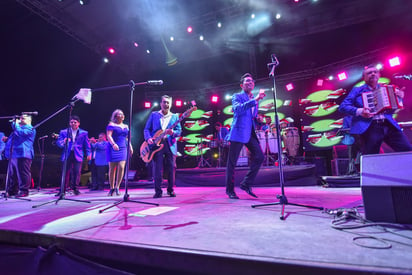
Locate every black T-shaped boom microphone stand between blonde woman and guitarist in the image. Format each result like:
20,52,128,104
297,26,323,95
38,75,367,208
97,80,159,213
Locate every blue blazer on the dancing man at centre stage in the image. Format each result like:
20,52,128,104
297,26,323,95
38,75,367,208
228,91,259,143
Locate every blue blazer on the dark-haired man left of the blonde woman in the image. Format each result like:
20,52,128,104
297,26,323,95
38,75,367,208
56,128,91,162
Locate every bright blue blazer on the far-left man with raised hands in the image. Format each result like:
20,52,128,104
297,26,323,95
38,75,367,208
4,122,36,159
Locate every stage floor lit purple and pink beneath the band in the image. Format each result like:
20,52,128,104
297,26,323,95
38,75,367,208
0,186,412,274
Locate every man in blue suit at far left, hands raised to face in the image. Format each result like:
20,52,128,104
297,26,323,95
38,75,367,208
4,115,36,197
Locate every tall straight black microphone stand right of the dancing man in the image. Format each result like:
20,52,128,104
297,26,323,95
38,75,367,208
252,54,324,220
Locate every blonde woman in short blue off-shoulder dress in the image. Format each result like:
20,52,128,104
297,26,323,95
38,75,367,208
106,109,133,196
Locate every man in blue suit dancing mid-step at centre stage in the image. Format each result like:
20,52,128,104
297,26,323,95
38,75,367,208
226,73,266,199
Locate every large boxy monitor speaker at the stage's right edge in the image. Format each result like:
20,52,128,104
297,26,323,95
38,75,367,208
361,152,412,224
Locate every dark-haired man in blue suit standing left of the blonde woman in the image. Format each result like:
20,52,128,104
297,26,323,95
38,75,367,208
56,116,91,195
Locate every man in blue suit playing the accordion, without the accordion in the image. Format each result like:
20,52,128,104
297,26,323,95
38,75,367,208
339,67,412,154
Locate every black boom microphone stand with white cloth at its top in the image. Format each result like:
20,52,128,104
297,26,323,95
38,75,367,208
32,99,90,208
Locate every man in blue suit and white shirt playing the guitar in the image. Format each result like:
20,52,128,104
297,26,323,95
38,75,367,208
144,95,182,198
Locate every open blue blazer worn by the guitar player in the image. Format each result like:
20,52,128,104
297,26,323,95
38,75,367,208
143,111,182,155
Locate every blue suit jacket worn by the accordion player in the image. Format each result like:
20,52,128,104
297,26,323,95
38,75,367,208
339,84,401,134
